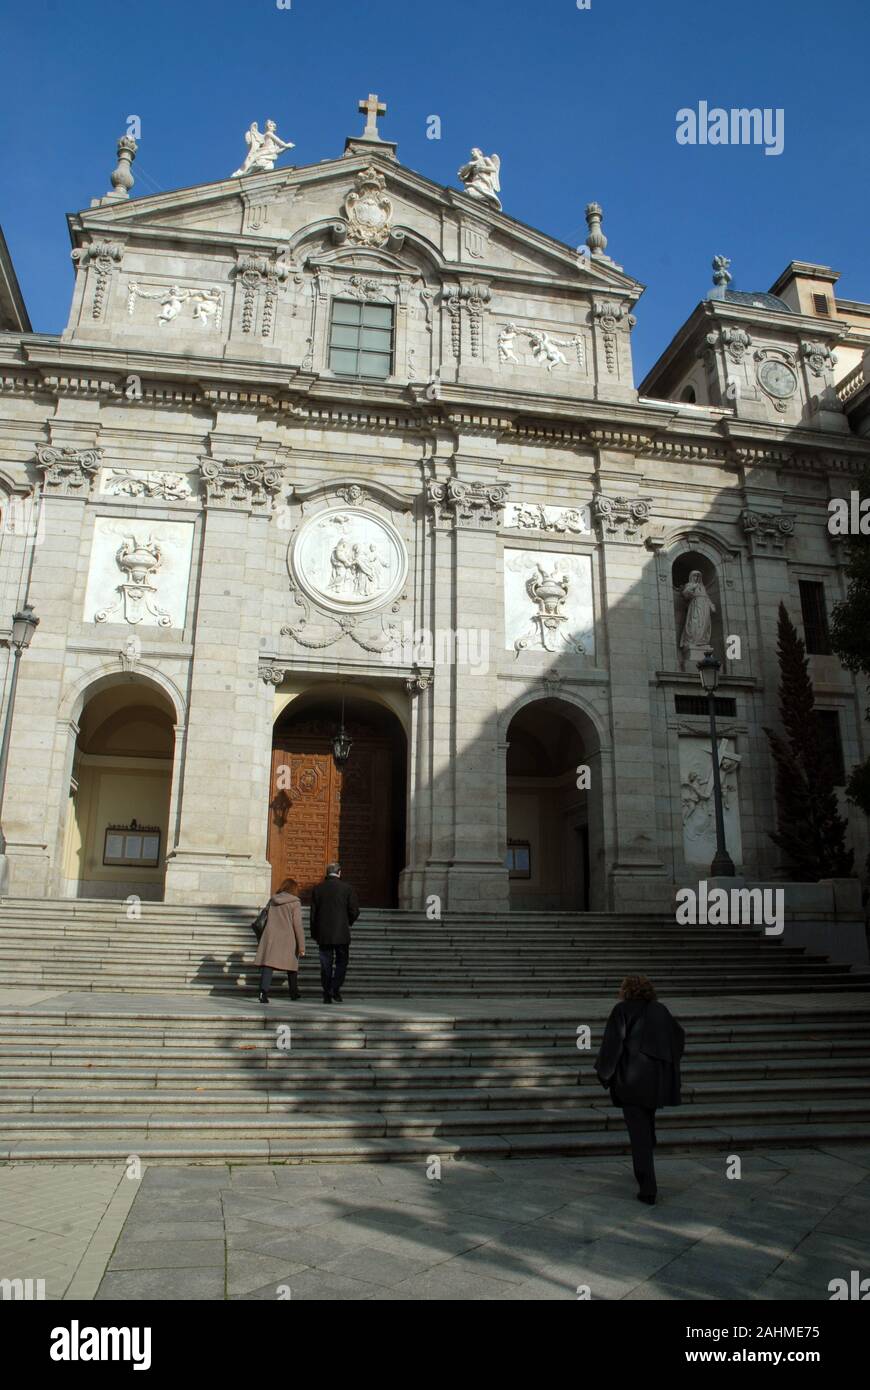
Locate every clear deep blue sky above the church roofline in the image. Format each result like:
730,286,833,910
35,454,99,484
0,0,870,379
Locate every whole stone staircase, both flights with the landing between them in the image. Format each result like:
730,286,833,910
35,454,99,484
0,899,870,1163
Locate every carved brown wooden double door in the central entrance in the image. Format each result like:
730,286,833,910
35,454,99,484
267,726,402,908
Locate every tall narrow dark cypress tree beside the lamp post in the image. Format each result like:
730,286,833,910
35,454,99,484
764,603,855,883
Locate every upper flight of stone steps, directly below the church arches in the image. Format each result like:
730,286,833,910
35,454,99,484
0,898,870,1001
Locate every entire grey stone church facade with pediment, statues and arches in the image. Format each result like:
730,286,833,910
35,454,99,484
0,99,870,913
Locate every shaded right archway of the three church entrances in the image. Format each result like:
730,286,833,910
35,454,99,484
506,698,605,912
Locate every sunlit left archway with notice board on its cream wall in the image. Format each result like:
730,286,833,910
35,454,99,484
63,677,175,901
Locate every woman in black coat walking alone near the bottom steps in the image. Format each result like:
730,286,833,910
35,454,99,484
595,974,685,1207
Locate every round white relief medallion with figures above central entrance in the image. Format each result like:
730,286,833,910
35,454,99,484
288,507,407,613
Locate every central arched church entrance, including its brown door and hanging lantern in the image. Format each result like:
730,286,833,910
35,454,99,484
267,691,407,908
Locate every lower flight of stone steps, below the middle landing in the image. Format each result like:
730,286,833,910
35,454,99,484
0,1001,870,1162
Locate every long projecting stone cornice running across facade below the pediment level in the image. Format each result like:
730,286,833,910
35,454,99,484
0,335,870,477
